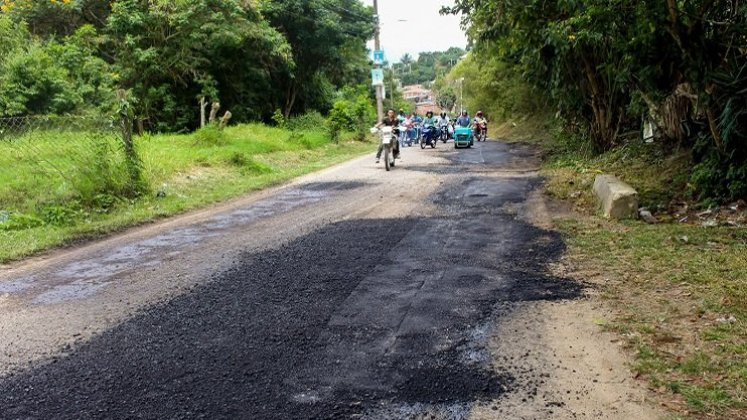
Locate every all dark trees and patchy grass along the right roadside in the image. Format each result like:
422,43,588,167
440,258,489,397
444,0,747,419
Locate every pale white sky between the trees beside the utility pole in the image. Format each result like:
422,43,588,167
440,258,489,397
361,0,467,63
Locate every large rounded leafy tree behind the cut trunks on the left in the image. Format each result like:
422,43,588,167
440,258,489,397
106,0,293,131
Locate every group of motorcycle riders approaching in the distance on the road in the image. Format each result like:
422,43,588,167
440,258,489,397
371,109,488,171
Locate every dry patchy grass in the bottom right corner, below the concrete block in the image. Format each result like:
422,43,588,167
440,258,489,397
559,218,747,418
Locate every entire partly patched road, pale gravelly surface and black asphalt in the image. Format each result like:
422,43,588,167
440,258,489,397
0,141,653,419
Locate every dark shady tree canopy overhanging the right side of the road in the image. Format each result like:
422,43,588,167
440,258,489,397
444,0,747,203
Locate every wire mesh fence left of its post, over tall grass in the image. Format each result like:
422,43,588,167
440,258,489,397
0,116,145,215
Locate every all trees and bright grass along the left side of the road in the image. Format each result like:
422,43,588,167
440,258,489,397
0,0,386,262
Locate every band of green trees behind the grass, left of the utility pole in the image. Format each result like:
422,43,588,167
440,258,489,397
0,0,375,131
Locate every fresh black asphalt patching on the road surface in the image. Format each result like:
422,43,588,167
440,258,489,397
0,142,582,419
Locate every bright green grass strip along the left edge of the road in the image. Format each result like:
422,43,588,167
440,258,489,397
0,124,373,262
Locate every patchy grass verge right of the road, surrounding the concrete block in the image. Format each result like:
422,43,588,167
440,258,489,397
542,120,747,419
